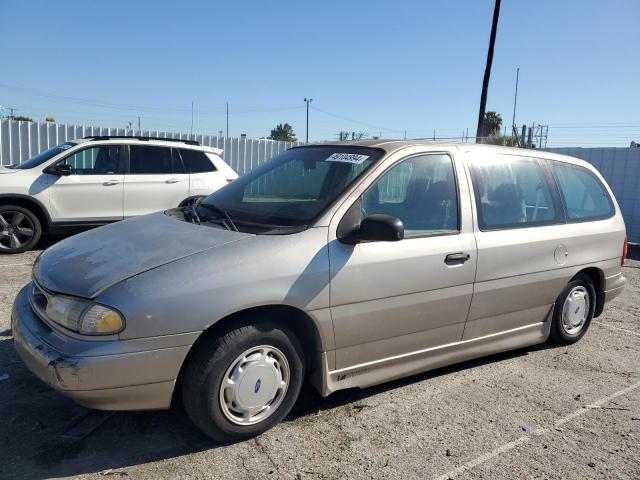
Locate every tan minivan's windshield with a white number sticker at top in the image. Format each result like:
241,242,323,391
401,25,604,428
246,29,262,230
198,145,384,230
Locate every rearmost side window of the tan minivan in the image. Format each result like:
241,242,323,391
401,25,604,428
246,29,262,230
551,162,614,221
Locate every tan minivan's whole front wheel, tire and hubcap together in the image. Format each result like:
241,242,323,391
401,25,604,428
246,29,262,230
182,320,304,441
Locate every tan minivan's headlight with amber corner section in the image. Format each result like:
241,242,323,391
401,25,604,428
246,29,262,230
46,295,124,335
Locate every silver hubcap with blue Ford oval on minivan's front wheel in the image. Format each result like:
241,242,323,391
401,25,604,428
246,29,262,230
219,345,290,425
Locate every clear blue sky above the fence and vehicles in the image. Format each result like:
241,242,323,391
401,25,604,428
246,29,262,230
0,0,640,146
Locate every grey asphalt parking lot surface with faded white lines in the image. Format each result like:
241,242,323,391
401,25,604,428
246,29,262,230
0,244,640,480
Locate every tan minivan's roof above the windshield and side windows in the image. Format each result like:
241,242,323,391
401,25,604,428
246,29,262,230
296,139,593,169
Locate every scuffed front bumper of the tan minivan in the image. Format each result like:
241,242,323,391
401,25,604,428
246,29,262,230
11,284,197,410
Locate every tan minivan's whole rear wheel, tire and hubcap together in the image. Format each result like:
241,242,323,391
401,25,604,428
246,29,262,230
549,274,596,345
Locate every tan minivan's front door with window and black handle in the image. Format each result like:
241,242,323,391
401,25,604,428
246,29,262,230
329,153,476,369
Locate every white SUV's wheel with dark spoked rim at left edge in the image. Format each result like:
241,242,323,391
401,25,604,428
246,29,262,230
0,205,42,254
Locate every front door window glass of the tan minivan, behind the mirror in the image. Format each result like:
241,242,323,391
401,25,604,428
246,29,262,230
362,154,459,236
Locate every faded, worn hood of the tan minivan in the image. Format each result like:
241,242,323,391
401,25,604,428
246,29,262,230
33,212,251,298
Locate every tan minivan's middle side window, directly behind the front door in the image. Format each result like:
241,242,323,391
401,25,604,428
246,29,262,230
471,156,563,230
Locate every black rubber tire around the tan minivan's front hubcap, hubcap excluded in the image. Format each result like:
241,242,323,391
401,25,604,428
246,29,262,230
182,318,305,442
